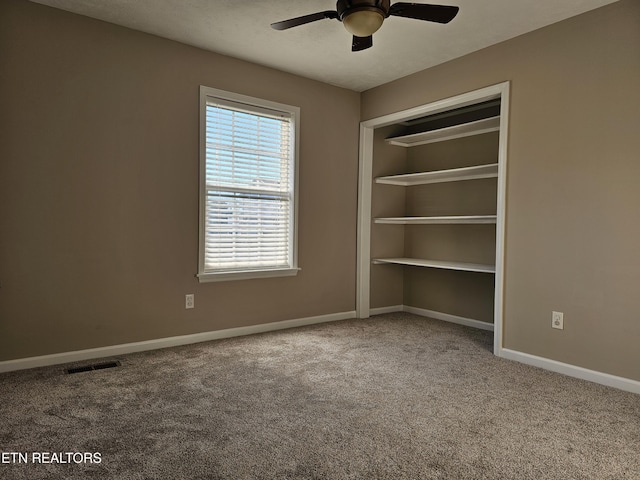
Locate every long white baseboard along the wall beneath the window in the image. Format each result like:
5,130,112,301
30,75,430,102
0,311,356,373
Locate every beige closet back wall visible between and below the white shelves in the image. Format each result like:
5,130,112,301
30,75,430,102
403,132,500,323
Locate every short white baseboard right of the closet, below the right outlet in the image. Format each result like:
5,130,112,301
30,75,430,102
500,348,640,394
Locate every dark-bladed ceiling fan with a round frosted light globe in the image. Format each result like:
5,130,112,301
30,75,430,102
271,0,460,52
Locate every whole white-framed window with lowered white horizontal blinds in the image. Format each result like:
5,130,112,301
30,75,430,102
198,87,300,282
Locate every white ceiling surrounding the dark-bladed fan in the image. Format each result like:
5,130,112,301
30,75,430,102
32,0,617,91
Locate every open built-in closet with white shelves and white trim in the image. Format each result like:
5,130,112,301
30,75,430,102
356,82,509,355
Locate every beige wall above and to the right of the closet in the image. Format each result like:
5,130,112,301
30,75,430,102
362,0,640,380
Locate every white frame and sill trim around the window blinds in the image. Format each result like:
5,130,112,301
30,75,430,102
197,86,300,283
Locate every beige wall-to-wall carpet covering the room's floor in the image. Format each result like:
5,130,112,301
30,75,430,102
0,314,640,480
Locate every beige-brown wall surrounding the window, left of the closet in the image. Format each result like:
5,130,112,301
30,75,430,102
0,0,360,360
